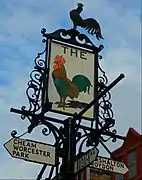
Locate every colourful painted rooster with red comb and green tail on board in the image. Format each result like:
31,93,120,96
52,55,92,109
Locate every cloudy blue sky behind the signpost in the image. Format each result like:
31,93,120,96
0,0,141,179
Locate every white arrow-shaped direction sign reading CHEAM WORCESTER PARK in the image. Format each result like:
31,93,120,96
4,138,55,165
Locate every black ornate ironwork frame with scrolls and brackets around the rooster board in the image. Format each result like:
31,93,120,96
11,28,124,180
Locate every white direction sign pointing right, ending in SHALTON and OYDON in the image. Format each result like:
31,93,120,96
90,156,128,174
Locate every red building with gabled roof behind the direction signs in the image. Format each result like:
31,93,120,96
112,128,142,180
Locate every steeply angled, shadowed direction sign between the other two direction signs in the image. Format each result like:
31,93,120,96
74,147,99,173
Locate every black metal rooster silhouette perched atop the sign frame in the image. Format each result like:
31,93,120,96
70,3,104,40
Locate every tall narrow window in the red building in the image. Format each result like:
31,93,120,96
128,151,137,179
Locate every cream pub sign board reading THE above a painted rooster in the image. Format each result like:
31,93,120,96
45,40,97,118
